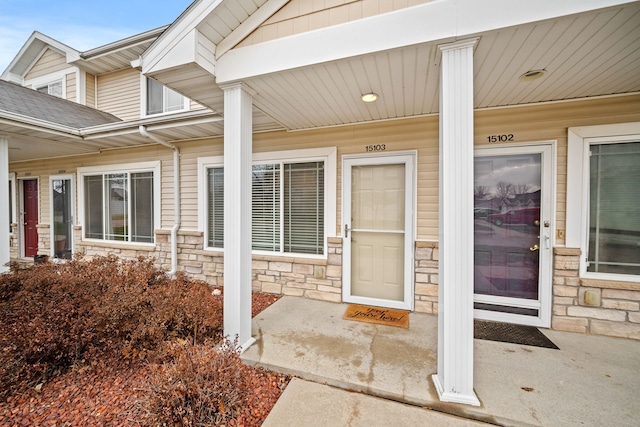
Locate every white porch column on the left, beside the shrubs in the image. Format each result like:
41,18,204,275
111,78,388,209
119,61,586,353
223,83,255,351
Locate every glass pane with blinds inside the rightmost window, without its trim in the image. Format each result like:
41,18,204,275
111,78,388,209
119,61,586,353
587,142,640,275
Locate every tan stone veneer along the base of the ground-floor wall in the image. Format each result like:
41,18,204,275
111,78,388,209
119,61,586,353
25,224,640,340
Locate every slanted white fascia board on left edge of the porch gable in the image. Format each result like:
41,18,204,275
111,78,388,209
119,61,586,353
142,0,223,74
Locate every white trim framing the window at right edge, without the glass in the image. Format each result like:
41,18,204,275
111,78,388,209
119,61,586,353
566,122,640,282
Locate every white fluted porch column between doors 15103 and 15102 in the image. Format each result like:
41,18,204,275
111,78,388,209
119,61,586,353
433,39,480,406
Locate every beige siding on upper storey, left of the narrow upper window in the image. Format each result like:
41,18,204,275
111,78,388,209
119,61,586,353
97,69,140,120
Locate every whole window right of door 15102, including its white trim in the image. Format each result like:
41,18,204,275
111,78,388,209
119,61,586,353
565,122,640,282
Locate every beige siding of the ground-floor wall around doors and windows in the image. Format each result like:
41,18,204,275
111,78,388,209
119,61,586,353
10,95,640,245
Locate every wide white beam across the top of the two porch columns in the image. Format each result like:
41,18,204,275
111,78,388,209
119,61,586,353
216,0,629,84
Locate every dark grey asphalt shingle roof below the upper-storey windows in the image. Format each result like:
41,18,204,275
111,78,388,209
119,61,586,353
0,80,122,129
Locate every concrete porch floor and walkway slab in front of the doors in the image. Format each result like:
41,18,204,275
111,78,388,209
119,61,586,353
242,296,640,426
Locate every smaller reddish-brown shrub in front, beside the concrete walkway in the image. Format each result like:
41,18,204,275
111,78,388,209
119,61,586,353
147,341,251,427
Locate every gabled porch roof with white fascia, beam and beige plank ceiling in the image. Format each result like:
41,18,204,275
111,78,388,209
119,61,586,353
141,0,640,131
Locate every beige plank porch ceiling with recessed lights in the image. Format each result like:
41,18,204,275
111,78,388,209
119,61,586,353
163,2,640,130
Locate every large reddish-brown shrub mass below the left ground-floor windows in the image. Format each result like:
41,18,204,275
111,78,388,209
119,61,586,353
0,256,222,400
